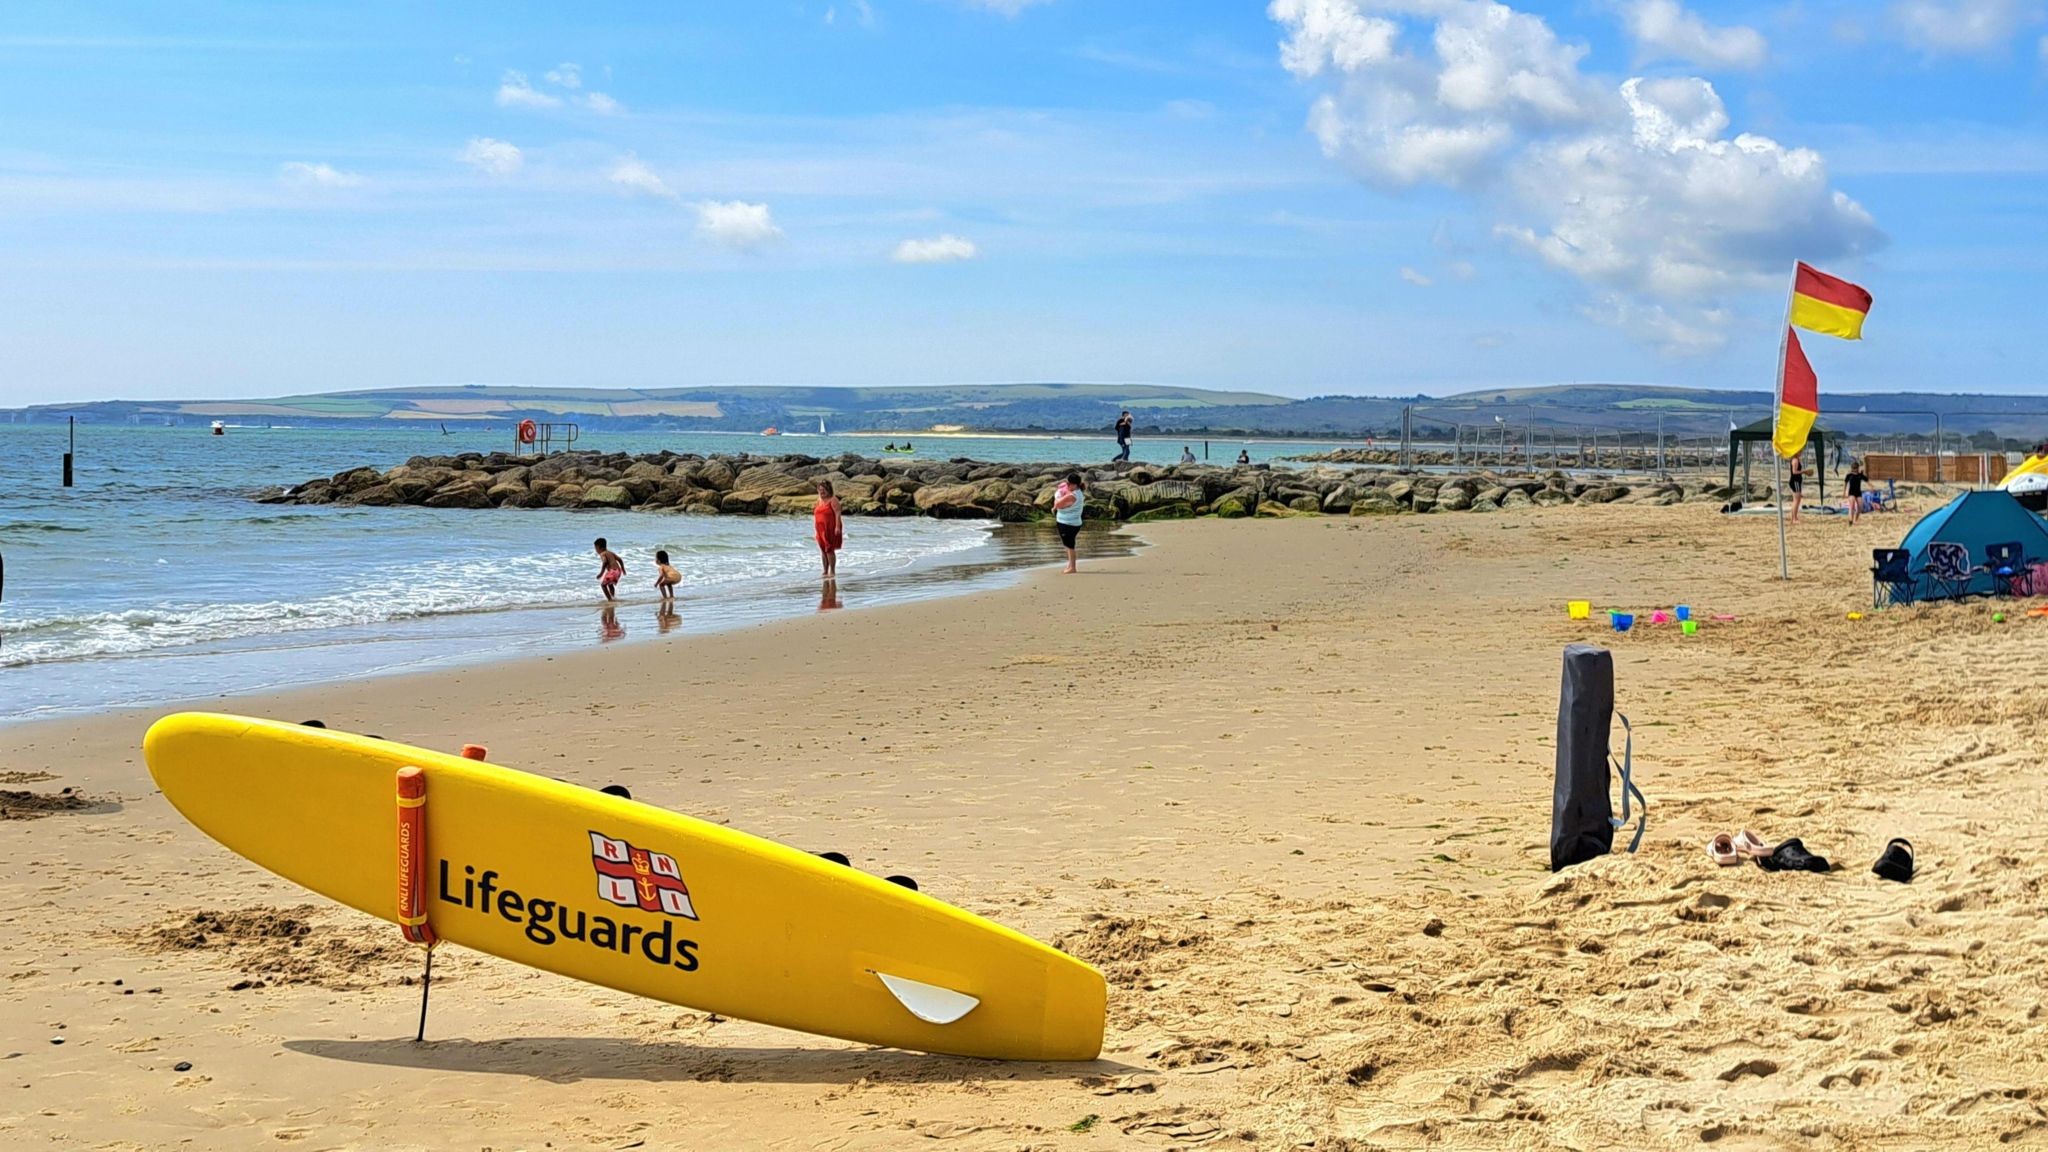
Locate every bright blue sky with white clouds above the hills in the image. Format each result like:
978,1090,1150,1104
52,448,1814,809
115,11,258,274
0,0,2048,406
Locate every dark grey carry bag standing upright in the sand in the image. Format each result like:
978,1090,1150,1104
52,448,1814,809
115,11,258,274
1550,644,1614,871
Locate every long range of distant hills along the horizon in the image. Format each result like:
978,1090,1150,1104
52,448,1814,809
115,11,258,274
12,383,2048,441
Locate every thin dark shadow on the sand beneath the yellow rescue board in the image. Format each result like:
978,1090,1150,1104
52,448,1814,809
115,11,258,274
285,1035,1143,1084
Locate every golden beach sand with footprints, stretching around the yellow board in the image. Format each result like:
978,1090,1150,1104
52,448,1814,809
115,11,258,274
0,504,2048,1152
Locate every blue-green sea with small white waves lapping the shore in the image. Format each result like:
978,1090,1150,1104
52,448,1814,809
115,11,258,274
0,422,1346,724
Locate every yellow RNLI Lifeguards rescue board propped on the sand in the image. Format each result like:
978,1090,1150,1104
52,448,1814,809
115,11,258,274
143,713,1106,1060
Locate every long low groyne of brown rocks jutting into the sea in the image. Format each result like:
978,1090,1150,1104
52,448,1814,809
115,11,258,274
262,453,1769,523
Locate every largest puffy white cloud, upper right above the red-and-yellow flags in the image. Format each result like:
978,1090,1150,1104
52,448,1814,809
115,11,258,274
1268,0,1884,353
